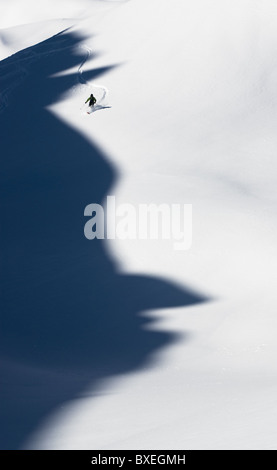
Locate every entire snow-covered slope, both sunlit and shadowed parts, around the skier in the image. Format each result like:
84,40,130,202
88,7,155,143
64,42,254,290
0,0,277,449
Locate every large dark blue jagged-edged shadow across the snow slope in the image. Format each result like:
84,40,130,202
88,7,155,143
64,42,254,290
0,32,206,449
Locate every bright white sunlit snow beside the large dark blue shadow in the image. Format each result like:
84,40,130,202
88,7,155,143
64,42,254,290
0,0,277,449
